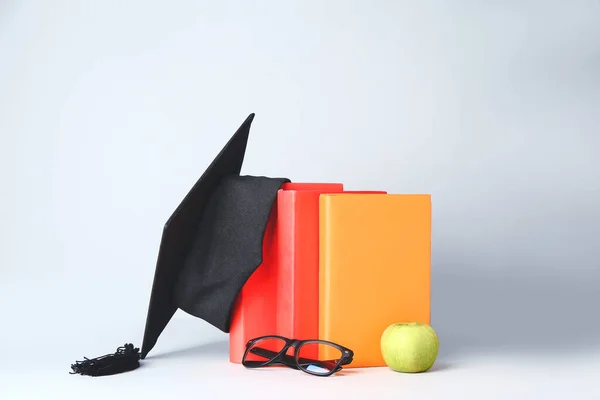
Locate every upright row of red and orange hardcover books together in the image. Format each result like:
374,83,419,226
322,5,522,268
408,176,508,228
230,183,431,367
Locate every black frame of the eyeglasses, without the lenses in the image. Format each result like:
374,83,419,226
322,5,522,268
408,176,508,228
242,335,354,377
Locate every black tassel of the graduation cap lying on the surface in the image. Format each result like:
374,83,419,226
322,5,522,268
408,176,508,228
69,343,140,376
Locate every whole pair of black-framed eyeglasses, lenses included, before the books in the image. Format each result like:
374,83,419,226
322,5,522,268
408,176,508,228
242,336,354,376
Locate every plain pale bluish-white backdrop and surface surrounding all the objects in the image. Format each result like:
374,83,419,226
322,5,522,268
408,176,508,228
0,0,600,399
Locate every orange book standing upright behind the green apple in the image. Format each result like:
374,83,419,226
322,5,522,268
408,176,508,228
319,194,431,367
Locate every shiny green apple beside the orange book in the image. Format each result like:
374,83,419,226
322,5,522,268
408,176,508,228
381,322,439,373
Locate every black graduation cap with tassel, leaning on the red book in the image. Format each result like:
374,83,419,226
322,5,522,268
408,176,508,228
71,114,290,376
